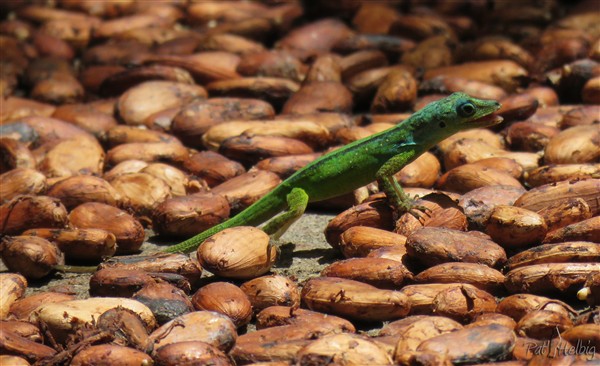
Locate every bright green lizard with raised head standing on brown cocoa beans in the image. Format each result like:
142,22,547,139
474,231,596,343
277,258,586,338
166,93,502,253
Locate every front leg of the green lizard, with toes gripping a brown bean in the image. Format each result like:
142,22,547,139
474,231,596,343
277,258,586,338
375,153,426,218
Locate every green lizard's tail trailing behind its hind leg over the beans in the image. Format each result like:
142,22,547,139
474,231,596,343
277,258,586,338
164,186,287,253
